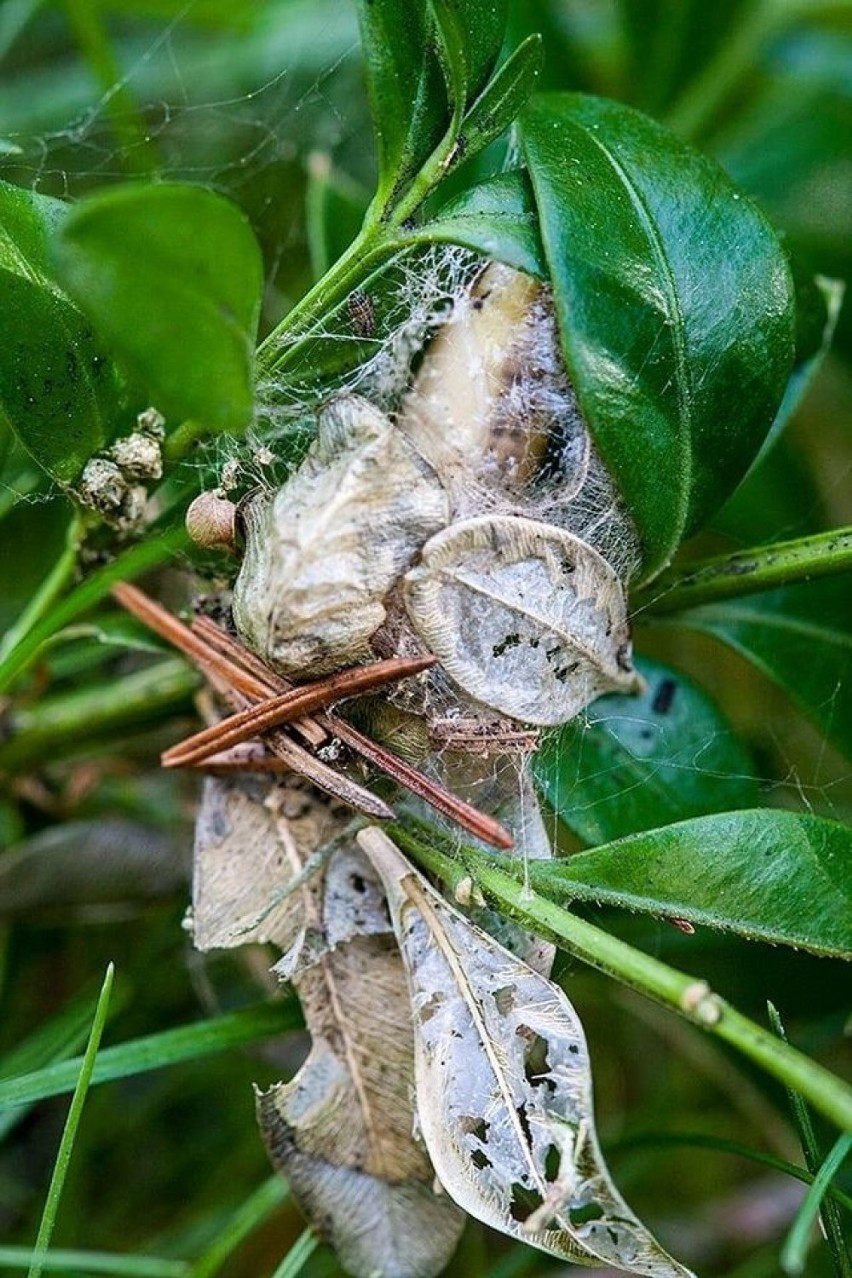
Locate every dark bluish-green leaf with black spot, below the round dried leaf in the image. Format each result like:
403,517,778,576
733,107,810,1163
534,658,757,845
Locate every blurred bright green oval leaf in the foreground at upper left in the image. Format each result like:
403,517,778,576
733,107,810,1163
54,184,263,431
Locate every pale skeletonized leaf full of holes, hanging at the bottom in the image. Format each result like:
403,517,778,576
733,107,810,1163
359,828,688,1278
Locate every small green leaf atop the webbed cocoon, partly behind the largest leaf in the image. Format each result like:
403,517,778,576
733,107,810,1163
413,169,547,277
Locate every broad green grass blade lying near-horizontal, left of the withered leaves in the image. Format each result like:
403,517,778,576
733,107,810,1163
0,998,303,1109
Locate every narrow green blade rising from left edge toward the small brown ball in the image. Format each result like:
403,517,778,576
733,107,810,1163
0,527,189,693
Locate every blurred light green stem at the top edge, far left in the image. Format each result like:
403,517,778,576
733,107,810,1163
57,0,158,175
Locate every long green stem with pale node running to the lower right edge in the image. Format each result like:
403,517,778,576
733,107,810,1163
392,827,852,1130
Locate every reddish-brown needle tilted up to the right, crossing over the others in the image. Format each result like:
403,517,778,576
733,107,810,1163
161,656,436,768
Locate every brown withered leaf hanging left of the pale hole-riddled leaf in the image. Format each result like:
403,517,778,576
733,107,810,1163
258,937,464,1278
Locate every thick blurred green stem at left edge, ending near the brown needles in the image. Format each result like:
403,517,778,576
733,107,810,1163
0,657,199,772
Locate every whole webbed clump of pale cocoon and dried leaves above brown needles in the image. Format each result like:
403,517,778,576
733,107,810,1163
218,265,637,743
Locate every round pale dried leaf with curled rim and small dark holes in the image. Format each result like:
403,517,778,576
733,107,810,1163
405,515,639,725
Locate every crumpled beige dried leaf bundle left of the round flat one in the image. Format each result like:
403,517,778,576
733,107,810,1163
234,395,448,677
